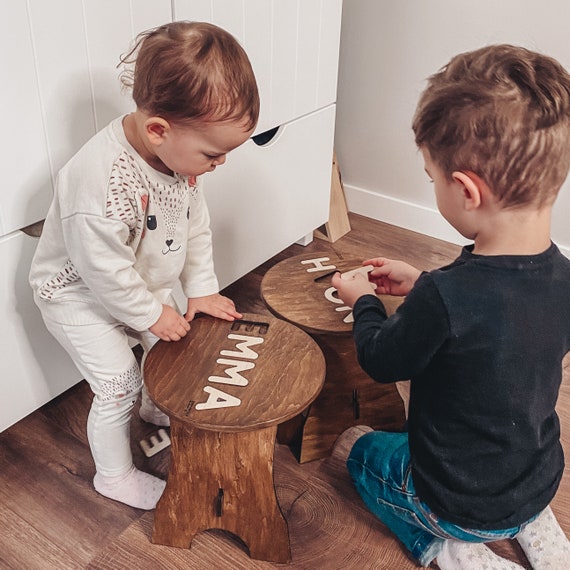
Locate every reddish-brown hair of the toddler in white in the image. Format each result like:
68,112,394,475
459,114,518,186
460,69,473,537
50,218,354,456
121,22,259,128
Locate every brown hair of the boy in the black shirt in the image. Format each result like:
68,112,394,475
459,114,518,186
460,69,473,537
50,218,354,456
413,45,570,207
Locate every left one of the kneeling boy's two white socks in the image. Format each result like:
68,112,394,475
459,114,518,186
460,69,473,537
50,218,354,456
437,540,524,570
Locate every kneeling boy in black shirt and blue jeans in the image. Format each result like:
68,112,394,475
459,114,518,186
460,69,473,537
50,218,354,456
333,45,570,570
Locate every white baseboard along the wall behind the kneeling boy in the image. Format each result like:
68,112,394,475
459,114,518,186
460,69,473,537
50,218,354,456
343,184,570,257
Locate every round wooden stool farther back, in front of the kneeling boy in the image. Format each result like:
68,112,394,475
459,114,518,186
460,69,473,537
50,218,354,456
261,253,405,463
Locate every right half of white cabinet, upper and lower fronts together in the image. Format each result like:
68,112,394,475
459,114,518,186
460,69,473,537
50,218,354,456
174,0,342,286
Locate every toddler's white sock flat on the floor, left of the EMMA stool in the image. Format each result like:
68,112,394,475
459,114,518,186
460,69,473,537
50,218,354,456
93,465,166,511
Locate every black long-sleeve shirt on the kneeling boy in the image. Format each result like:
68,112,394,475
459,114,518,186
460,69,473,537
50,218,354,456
354,244,570,529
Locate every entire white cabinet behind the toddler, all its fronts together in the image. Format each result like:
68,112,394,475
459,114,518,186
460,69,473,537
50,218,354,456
0,0,342,430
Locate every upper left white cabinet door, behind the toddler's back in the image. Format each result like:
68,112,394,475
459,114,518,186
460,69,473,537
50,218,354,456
0,0,172,236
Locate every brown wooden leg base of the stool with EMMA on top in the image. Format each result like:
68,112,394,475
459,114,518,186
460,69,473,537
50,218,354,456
152,419,291,562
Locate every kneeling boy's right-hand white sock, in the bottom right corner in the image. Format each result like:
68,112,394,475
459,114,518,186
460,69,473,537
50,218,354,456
516,507,570,570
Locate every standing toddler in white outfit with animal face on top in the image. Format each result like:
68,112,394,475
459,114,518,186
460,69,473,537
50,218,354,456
30,22,259,509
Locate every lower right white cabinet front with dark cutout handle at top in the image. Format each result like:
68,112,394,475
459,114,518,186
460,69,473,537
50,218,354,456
204,105,335,287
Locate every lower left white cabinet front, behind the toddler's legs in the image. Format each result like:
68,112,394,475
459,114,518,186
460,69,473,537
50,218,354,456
0,232,81,431
